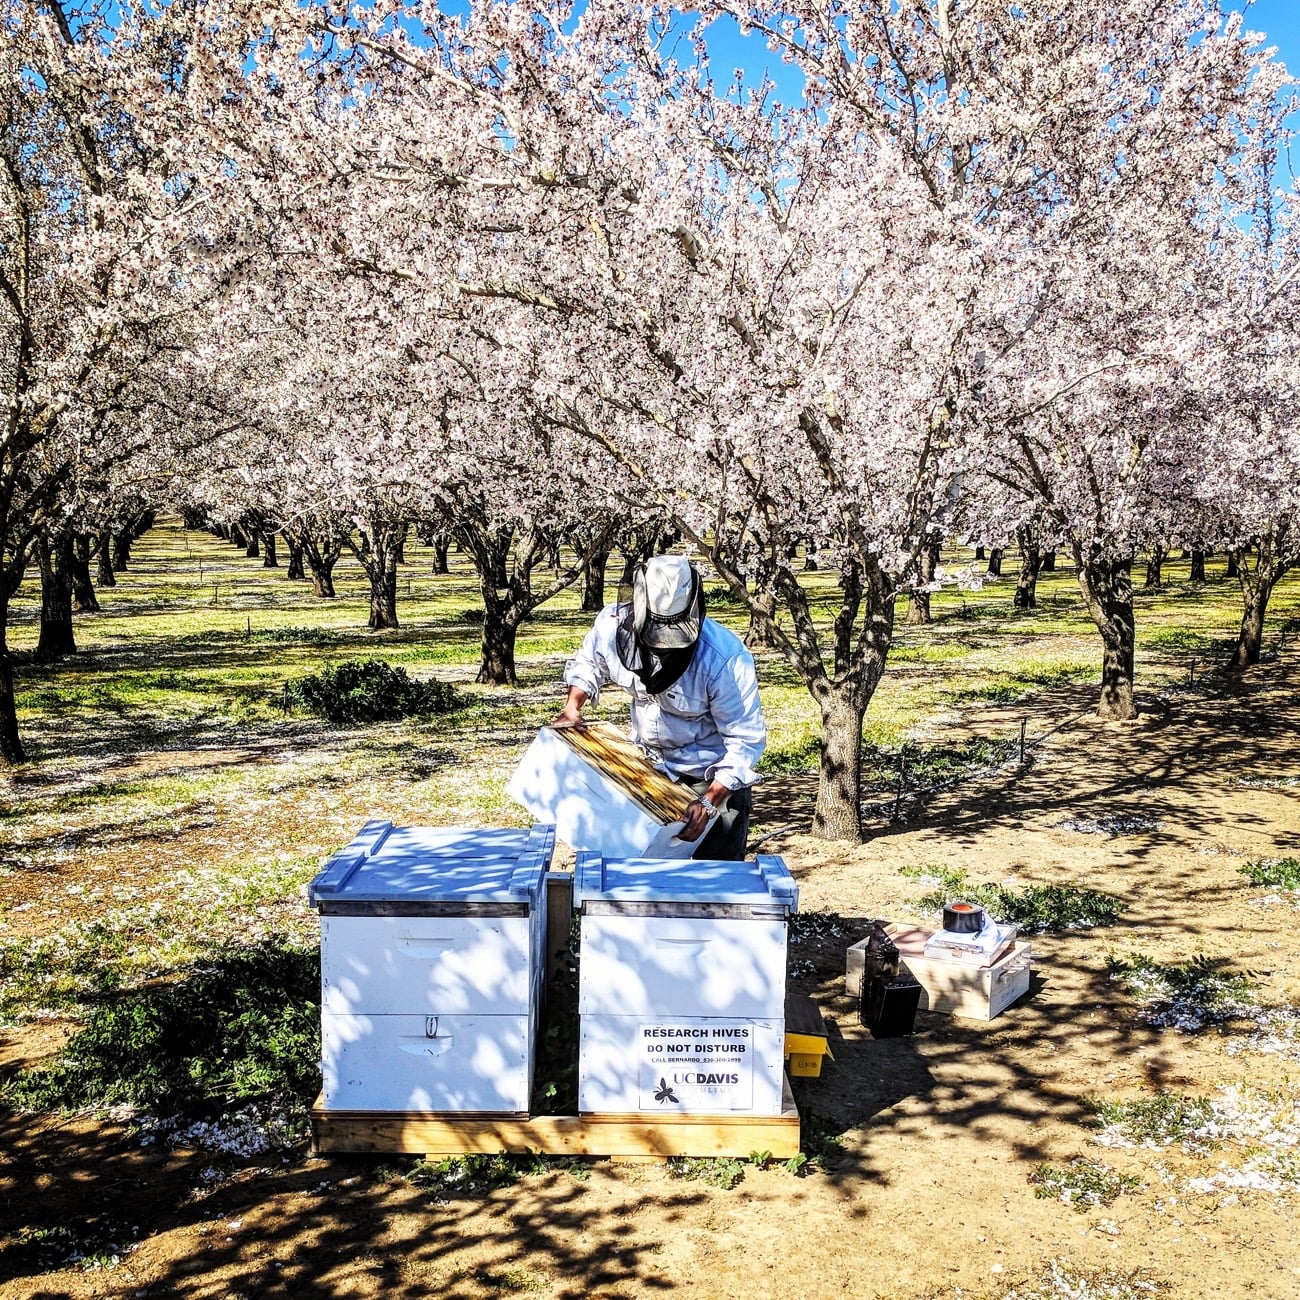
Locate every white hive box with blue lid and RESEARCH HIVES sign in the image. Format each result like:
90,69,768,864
573,854,798,1115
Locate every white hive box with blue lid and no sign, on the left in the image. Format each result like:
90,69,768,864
309,822,555,1114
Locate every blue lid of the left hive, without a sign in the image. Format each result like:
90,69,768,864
308,822,555,906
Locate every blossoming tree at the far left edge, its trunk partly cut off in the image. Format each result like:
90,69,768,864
0,0,263,762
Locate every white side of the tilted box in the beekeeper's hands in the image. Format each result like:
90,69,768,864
506,723,699,858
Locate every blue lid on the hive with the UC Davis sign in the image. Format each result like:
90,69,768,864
573,853,800,913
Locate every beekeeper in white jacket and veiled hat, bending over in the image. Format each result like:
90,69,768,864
554,555,767,862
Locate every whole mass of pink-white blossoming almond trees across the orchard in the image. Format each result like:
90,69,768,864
0,0,1300,837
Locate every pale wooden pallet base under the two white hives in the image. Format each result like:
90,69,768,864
312,1080,800,1160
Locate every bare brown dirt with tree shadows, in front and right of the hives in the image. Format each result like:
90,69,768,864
0,662,1300,1300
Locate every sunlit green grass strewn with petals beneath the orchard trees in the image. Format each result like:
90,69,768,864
0,524,1300,1081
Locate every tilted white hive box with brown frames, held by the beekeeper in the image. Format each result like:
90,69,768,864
506,723,698,858
